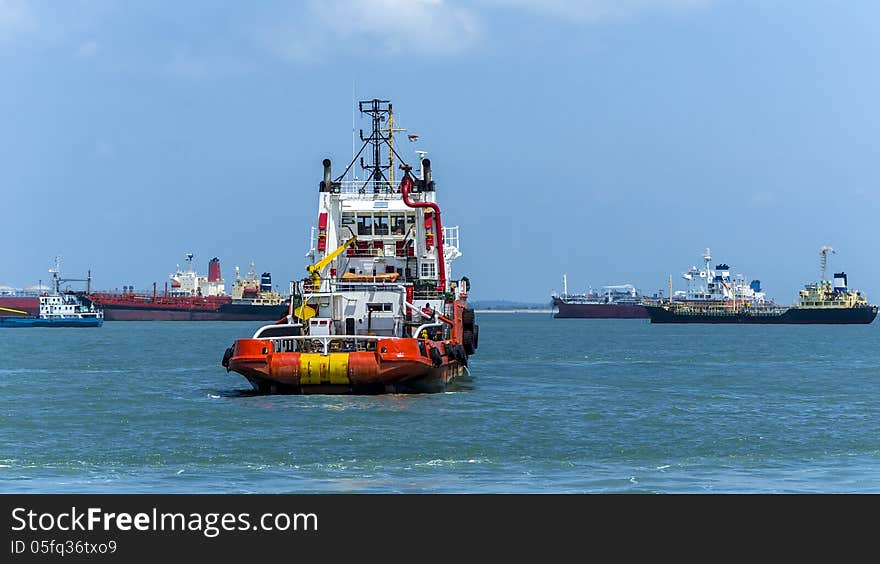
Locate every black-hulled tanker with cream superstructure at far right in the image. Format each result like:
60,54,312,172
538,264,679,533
646,247,878,325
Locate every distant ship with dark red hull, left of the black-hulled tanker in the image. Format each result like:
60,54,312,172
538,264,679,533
551,274,648,319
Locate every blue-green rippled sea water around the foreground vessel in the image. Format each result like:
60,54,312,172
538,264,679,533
0,313,880,493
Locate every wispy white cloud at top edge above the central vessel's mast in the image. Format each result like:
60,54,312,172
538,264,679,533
267,0,481,61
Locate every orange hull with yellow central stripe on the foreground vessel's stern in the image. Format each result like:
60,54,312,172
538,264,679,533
230,338,467,394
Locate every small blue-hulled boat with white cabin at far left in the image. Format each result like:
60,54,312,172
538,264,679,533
0,259,104,327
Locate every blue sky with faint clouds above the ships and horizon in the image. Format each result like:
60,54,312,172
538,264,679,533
0,0,880,302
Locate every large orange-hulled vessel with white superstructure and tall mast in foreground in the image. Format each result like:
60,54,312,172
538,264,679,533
222,99,479,394
